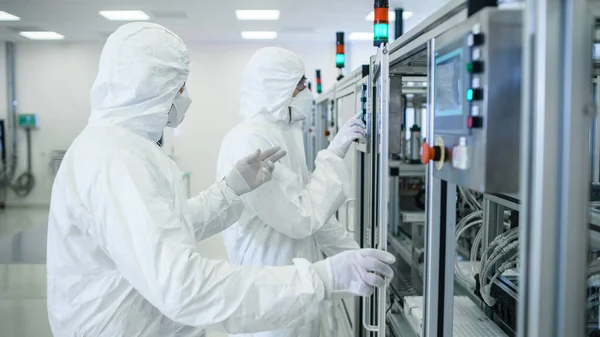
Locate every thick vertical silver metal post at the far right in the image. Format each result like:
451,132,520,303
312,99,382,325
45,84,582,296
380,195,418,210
518,0,594,337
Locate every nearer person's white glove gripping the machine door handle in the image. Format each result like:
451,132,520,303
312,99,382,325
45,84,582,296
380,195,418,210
313,245,396,300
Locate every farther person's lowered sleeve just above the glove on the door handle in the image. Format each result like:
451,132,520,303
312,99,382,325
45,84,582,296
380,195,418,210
315,217,360,257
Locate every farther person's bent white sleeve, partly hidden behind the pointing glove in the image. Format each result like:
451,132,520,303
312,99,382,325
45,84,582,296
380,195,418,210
219,135,350,239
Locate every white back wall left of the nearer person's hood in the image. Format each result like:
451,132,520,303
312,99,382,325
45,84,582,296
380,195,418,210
0,43,102,206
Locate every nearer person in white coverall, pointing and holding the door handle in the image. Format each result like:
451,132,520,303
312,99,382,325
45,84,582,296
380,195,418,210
47,23,394,337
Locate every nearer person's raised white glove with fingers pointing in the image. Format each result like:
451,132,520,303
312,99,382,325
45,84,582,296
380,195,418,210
225,146,287,196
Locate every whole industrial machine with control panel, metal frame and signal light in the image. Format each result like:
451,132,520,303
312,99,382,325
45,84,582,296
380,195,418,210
315,0,600,337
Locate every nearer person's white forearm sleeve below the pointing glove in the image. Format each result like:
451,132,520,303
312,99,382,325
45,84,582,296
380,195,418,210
187,180,244,241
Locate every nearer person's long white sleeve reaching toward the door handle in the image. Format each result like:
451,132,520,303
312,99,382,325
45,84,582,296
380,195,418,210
89,157,324,333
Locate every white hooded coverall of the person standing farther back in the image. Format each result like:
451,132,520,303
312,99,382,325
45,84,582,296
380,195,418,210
217,48,359,337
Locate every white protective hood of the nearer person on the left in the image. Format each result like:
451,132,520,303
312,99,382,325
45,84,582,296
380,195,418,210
89,23,189,141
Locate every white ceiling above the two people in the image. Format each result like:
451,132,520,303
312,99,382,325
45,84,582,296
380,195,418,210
0,0,446,42
